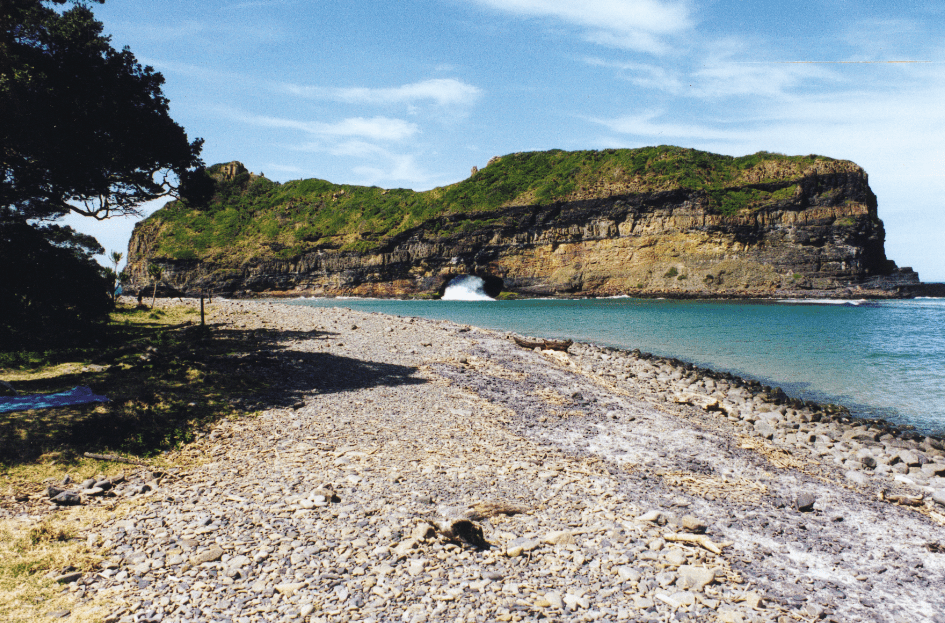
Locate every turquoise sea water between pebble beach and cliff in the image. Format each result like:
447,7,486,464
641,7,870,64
282,298,945,432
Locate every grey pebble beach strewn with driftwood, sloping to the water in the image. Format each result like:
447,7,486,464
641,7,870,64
46,299,945,623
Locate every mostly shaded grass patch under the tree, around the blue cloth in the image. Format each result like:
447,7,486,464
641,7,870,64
0,307,265,468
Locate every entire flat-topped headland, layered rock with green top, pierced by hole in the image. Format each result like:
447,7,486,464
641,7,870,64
121,147,918,297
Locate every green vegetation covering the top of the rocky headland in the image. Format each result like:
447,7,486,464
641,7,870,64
149,146,840,260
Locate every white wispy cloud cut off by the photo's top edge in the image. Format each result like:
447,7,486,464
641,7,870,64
474,0,693,52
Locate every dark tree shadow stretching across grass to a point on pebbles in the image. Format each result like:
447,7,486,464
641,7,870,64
0,325,425,465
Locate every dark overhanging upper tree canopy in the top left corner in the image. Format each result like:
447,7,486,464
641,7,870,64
0,0,203,220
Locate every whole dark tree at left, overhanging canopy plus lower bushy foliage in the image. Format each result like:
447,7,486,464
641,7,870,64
0,0,205,347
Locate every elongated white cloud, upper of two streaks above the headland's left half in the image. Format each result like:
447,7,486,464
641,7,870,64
283,78,482,106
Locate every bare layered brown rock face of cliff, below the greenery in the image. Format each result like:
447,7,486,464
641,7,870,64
128,152,918,297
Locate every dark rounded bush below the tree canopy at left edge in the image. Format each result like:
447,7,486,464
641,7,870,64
0,219,112,349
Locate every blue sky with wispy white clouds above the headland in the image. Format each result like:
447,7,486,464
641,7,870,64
70,0,945,281
